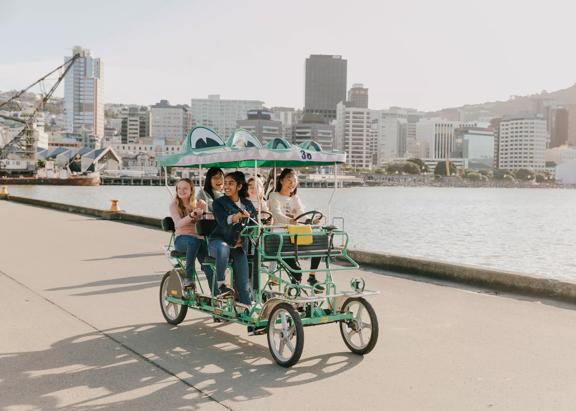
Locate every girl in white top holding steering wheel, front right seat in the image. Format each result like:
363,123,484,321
268,168,324,291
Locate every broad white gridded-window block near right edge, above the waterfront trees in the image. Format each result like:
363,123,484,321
498,118,548,170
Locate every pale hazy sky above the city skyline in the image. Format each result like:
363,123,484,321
0,0,576,110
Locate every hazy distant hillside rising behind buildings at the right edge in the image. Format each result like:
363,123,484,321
428,84,576,120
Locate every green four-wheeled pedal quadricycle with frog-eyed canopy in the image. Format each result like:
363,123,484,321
160,127,378,367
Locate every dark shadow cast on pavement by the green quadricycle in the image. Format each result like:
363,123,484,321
0,318,362,410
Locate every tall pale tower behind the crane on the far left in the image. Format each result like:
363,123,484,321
64,46,104,147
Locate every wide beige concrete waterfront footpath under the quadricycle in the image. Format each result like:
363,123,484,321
0,198,576,411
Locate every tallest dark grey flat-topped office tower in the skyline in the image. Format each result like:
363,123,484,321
304,54,348,120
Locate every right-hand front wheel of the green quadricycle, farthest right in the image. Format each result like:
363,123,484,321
340,297,378,355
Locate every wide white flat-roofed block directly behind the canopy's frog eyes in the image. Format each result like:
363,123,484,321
190,94,264,139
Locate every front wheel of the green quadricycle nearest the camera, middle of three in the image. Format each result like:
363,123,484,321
267,303,304,368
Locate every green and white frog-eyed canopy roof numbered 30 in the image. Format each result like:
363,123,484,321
159,126,346,168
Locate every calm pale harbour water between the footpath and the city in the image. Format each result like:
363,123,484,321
9,186,576,282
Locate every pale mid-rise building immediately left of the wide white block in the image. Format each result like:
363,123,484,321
150,100,192,141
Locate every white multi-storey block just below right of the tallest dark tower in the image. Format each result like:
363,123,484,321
336,102,374,168
